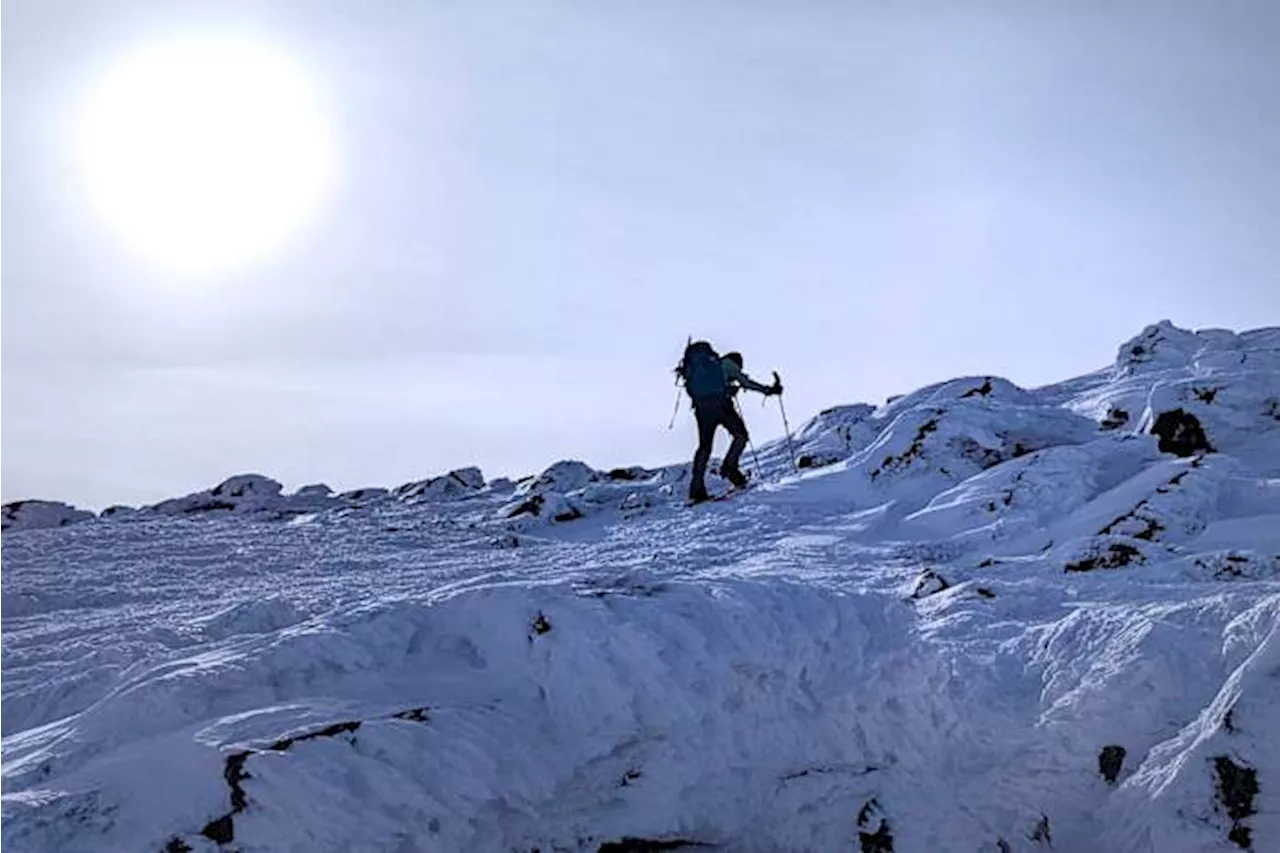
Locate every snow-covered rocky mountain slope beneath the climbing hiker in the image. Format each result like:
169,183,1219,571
0,324,1280,853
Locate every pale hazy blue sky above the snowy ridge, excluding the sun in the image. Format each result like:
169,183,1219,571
0,0,1280,507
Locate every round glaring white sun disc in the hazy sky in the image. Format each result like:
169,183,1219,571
77,40,332,272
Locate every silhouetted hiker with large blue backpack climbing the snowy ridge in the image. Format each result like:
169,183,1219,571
676,341,782,503
